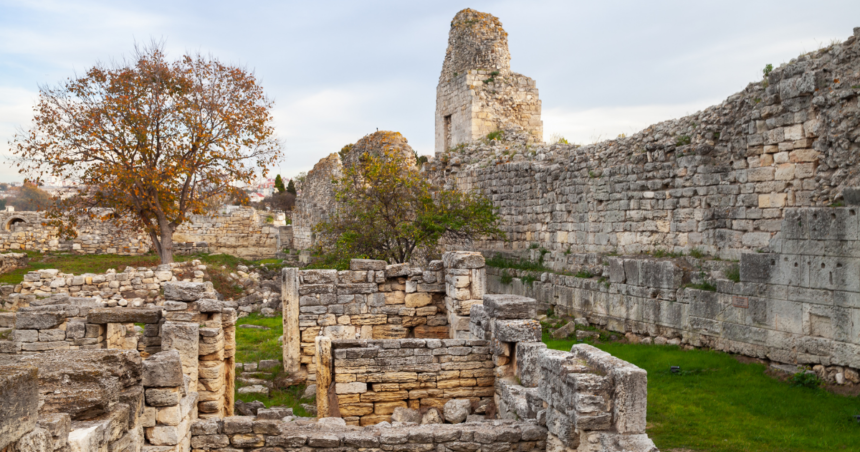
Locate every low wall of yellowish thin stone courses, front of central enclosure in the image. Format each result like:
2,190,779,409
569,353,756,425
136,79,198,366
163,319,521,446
316,338,495,425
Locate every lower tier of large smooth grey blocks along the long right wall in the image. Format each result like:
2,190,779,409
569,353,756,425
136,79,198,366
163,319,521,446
488,207,860,374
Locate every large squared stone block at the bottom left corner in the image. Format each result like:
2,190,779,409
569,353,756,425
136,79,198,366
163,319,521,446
0,366,39,450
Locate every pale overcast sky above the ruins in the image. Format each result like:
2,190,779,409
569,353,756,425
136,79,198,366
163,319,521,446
0,0,860,182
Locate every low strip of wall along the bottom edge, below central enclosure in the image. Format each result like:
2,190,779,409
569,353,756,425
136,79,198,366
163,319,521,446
191,416,546,452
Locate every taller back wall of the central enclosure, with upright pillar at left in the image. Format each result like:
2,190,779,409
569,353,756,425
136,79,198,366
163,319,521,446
281,252,485,380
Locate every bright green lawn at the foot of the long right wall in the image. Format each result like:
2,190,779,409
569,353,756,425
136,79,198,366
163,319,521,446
544,339,860,452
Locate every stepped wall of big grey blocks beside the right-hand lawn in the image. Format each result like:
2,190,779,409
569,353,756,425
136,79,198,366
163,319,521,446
470,295,657,452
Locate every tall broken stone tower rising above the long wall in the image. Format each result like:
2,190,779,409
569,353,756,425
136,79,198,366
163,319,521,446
435,9,543,155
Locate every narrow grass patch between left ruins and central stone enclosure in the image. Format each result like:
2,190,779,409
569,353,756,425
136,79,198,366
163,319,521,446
236,313,312,417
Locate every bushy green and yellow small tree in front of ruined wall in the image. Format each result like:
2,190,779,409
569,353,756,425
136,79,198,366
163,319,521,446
313,151,502,269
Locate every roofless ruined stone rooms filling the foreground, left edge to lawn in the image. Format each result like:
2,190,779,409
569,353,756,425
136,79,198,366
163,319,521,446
0,252,653,452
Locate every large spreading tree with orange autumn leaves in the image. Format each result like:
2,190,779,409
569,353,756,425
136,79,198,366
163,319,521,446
10,45,281,263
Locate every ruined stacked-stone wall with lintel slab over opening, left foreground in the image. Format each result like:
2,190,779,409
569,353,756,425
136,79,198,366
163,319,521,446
0,281,237,451
